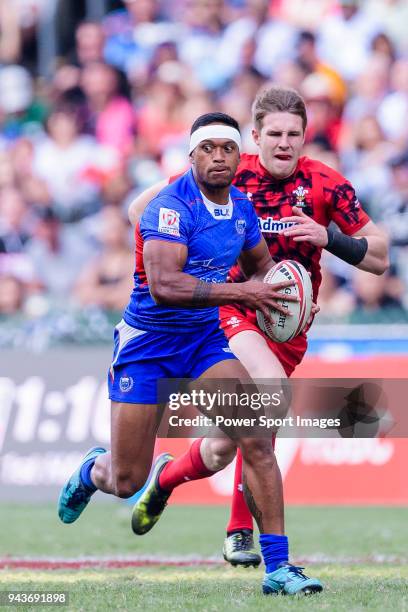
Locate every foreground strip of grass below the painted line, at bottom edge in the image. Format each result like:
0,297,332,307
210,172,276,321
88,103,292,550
1,566,408,612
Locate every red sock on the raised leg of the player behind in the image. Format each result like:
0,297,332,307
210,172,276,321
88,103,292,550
159,438,215,491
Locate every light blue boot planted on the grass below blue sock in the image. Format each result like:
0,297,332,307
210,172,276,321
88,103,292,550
262,562,323,595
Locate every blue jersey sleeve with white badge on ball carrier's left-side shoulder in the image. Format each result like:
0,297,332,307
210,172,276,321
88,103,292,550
140,195,193,244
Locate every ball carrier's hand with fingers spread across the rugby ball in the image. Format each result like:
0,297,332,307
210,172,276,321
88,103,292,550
240,280,299,321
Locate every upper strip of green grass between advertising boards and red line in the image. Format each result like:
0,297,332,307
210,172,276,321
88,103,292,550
0,501,408,558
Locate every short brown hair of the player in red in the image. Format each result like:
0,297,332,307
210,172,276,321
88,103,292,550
252,85,307,131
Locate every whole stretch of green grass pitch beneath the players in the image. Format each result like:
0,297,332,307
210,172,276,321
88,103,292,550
0,503,408,612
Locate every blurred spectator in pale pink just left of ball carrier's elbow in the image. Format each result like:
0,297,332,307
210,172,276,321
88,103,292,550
74,206,135,311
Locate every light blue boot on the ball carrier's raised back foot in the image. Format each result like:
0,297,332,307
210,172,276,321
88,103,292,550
58,446,106,523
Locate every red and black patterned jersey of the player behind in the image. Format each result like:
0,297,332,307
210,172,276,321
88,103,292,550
230,153,370,301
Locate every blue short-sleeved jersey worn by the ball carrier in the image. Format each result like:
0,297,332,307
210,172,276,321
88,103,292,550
124,170,261,333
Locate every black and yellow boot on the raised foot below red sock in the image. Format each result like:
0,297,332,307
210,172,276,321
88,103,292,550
132,453,174,535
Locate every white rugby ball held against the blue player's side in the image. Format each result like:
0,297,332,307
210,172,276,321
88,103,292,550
256,259,313,342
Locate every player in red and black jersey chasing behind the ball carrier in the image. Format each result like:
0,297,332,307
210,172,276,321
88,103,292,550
129,86,389,566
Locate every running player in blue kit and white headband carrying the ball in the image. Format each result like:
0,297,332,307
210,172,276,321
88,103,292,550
58,113,322,594
